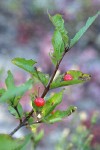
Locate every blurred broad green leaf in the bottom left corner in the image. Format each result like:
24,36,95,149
0,134,31,150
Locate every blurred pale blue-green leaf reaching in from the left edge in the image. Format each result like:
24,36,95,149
0,79,33,102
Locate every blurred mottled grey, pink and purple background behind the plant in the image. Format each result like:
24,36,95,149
0,0,100,150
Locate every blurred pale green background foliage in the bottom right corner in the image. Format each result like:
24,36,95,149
55,113,99,150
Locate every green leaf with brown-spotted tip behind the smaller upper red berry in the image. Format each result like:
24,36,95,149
50,70,91,89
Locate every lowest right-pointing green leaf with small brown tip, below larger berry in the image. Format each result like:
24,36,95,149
46,106,77,123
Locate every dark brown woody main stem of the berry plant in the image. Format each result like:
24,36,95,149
10,48,69,136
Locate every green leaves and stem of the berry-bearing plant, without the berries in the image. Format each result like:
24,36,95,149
0,13,99,150
